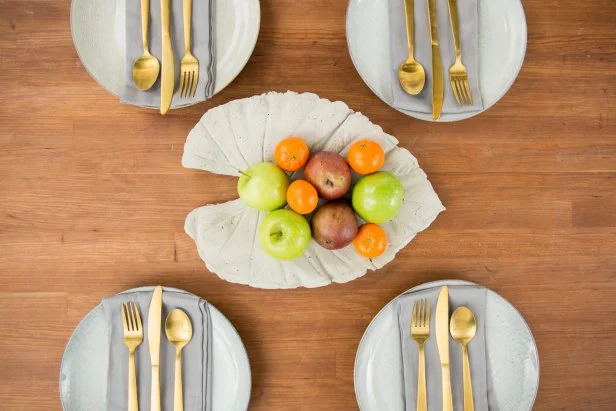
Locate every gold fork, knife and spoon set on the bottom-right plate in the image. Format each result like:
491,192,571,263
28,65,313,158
411,286,477,411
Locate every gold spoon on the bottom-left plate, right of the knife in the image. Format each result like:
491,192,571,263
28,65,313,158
165,308,192,411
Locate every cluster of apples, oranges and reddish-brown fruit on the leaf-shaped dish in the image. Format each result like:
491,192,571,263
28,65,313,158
237,137,404,260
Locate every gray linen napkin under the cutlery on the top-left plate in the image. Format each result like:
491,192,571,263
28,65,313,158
121,0,216,108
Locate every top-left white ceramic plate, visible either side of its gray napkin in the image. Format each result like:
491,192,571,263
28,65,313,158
71,0,261,108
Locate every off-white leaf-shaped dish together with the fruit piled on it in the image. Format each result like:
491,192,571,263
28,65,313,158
182,91,445,289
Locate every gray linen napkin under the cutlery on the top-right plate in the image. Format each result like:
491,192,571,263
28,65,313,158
389,0,483,114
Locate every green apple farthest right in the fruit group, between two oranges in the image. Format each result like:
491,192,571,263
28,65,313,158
353,171,404,224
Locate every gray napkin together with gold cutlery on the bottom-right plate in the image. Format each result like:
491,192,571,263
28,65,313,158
395,286,489,411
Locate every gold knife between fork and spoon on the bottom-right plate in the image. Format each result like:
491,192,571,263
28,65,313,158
434,286,453,411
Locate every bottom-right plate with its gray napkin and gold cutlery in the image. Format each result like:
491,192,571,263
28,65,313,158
355,280,539,411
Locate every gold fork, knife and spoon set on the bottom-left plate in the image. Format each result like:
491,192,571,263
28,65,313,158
122,286,192,411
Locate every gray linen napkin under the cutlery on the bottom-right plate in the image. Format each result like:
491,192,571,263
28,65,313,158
394,285,492,411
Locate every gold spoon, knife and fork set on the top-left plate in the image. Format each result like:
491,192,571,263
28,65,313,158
133,0,199,114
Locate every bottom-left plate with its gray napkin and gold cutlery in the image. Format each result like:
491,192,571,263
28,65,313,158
60,286,251,411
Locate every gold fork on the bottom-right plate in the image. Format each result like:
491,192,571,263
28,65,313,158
411,300,430,411
